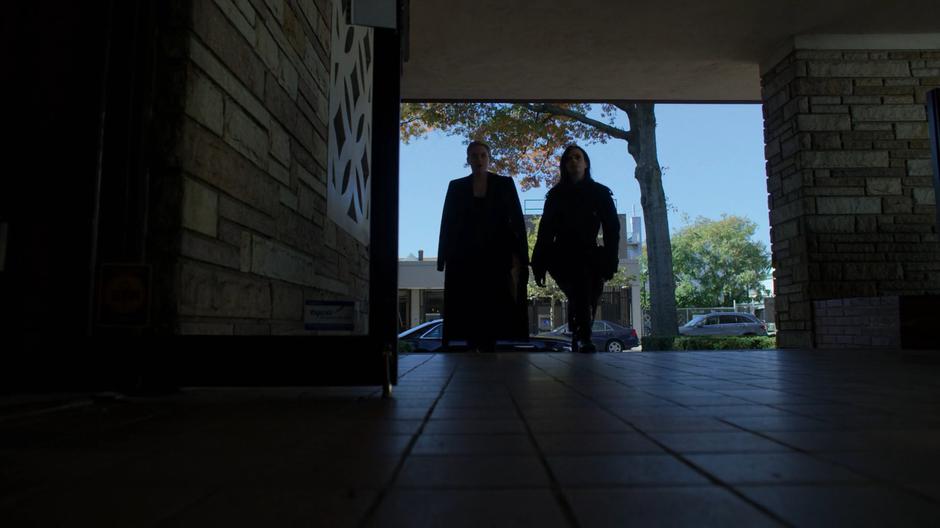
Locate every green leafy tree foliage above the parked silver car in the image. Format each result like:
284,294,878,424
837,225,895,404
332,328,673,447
672,215,770,307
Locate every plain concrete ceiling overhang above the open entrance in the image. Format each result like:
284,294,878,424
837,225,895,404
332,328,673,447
402,0,940,102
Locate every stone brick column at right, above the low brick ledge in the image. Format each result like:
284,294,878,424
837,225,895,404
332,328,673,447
762,36,940,347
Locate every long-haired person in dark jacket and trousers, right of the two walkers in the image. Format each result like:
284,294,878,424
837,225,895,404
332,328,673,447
532,145,620,352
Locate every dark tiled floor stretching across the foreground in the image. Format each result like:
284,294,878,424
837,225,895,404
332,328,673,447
0,351,940,527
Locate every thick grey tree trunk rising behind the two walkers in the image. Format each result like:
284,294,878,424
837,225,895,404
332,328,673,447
620,103,679,336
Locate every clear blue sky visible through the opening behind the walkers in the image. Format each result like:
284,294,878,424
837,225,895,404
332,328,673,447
398,104,770,286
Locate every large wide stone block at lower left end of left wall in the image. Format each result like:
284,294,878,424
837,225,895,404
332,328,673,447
177,261,271,319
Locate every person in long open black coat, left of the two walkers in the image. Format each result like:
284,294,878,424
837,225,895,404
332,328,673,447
437,141,529,351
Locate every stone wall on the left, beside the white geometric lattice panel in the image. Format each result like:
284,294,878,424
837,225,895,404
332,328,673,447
165,0,369,334
